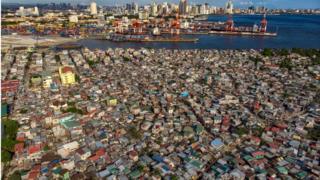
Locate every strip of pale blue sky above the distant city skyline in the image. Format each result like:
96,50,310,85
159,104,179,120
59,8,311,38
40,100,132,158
2,0,320,9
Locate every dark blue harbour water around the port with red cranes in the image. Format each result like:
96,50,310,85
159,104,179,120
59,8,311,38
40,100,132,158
78,15,320,49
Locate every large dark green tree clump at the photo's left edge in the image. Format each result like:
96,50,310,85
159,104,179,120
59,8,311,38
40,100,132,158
1,119,19,162
